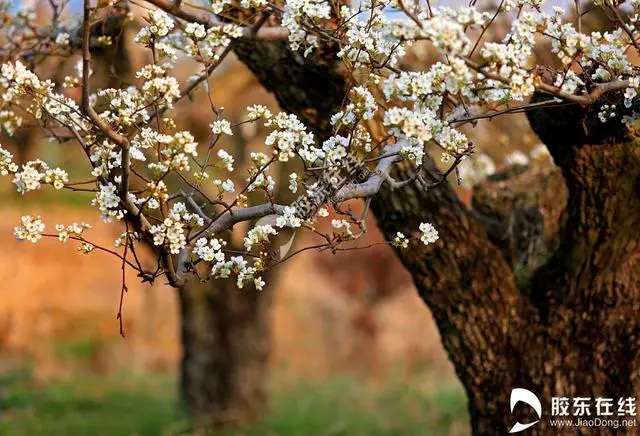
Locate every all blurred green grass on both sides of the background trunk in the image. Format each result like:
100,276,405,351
0,375,468,436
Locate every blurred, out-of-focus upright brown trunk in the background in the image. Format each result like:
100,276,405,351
179,278,271,428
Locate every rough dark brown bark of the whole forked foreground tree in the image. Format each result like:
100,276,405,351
237,36,640,435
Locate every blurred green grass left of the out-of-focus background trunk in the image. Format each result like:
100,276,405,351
0,376,186,436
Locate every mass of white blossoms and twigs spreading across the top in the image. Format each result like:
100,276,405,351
5,0,640,289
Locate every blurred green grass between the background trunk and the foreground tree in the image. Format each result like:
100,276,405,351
238,378,466,436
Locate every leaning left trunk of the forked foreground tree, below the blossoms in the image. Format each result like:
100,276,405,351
372,162,535,434
